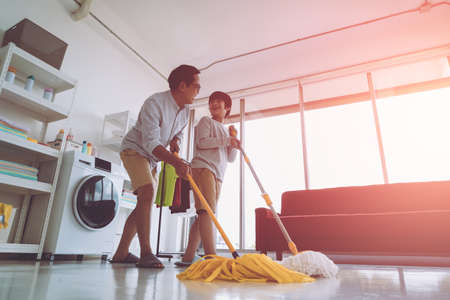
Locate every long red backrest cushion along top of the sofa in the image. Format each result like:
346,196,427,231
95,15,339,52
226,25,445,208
281,181,450,216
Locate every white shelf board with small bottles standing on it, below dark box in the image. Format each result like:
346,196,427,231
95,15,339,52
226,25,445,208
0,82,69,122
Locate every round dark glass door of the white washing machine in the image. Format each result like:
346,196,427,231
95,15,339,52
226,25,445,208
73,175,119,230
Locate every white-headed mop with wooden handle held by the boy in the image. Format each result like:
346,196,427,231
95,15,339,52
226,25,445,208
229,125,339,278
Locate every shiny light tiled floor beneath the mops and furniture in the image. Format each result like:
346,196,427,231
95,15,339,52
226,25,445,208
0,260,450,300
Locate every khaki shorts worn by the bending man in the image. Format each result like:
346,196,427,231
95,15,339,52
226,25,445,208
120,149,157,193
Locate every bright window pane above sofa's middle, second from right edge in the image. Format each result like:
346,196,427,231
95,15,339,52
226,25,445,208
305,101,383,188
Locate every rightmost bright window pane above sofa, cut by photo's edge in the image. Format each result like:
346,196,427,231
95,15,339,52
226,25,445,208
377,88,450,182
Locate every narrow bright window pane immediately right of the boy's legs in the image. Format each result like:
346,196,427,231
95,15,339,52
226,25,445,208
216,123,240,249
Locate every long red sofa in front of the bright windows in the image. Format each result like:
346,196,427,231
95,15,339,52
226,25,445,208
255,181,450,265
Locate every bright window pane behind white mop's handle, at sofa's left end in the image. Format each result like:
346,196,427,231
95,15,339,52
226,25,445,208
244,113,305,249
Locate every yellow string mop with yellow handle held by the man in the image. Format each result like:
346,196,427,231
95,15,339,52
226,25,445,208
175,153,315,283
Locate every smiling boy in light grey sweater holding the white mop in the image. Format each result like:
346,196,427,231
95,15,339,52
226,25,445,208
175,92,239,266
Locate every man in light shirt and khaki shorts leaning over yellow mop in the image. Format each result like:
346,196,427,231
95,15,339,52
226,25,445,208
111,65,200,268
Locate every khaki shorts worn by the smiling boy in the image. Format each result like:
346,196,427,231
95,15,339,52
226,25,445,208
192,168,222,212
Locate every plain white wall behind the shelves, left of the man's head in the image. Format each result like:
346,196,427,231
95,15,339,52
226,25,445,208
0,0,168,163
